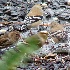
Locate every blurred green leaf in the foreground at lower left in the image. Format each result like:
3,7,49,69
0,34,39,70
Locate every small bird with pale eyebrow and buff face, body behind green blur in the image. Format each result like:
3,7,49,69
24,31,48,47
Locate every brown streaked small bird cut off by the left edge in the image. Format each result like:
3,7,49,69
0,31,20,49
